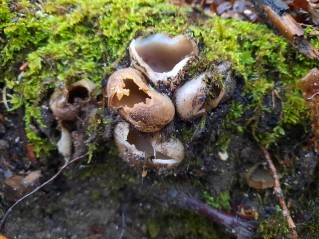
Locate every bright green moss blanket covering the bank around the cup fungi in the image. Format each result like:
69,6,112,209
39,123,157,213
0,0,315,155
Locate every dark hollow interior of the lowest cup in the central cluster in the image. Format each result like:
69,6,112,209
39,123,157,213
127,129,170,159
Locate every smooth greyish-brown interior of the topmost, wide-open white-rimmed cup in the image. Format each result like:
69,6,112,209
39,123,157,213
136,37,193,73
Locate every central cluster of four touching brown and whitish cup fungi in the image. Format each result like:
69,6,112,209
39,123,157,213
105,33,235,169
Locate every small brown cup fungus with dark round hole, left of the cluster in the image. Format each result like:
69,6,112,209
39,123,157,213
50,80,95,121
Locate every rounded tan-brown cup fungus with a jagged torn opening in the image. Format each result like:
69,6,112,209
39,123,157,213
106,68,175,132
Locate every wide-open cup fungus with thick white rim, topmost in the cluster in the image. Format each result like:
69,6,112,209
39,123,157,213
129,33,198,90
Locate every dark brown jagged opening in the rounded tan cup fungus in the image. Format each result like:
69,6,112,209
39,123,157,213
112,79,151,108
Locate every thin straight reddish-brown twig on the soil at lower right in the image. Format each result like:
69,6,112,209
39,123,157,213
262,147,298,239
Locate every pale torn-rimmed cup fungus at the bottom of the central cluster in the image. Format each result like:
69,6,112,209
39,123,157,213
114,122,184,169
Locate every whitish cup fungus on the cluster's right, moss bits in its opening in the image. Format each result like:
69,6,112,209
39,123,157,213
175,62,236,120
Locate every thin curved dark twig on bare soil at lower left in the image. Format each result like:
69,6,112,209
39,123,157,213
0,153,88,234
